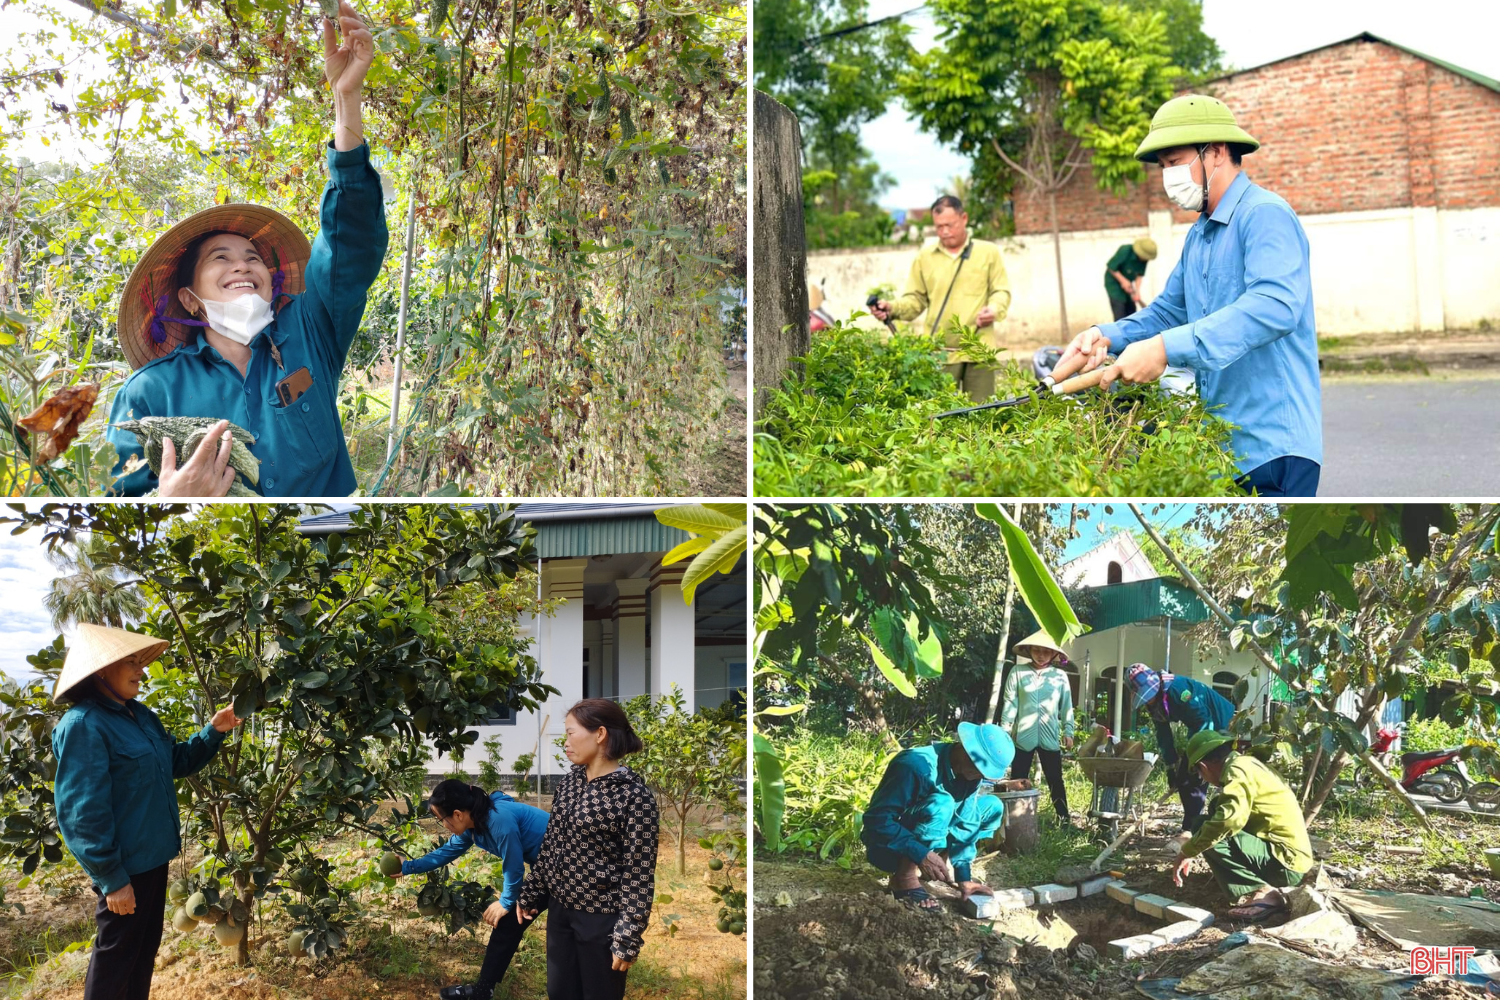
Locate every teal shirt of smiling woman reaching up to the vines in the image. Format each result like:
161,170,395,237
108,144,389,496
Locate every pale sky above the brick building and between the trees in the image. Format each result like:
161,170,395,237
861,0,1500,209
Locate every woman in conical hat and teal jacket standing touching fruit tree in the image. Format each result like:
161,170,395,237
53,625,240,1000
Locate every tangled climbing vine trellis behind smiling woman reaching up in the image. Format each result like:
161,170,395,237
0,0,746,495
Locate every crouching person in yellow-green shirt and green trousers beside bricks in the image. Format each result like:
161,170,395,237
1173,730,1313,921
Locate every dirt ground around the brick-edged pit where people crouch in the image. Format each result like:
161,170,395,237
753,805,1500,1000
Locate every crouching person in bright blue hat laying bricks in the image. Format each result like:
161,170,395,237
860,723,1029,912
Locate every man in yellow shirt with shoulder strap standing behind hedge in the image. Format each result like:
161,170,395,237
870,195,1011,403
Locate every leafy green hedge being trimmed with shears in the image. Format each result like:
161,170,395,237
755,325,1239,496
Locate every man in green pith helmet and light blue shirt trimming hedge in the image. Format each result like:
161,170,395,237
1053,94,1323,496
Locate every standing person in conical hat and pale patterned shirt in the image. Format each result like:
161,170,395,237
1001,630,1074,826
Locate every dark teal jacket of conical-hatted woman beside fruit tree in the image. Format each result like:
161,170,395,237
53,699,224,894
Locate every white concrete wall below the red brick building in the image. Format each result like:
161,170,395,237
807,207,1500,345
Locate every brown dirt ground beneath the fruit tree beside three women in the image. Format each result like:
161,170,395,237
0,826,747,1000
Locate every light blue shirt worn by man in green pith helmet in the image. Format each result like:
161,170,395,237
1100,174,1323,472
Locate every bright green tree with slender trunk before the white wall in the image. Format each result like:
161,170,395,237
899,0,1181,336
